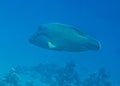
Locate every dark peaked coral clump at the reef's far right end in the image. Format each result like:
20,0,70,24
83,68,112,86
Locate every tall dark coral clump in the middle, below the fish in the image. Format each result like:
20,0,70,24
56,62,80,86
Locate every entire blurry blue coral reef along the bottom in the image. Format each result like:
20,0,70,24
0,61,112,86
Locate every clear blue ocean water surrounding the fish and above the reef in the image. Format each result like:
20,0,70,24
0,0,120,86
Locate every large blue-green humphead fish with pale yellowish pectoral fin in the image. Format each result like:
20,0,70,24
29,23,100,52
